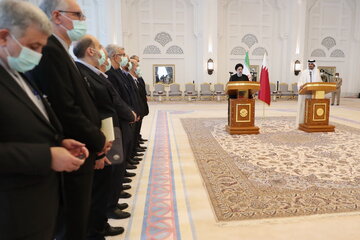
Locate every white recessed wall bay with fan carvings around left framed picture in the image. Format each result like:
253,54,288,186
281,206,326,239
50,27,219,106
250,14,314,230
122,0,197,89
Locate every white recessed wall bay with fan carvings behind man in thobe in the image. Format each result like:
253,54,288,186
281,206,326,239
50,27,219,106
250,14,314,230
306,0,360,95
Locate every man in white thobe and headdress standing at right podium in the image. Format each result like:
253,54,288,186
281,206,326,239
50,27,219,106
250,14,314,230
296,60,322,127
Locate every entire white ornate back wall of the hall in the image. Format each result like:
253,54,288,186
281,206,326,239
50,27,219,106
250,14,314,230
24,0,360,96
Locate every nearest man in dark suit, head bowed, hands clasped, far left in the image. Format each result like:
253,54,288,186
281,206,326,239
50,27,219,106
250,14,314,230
0,1,88,240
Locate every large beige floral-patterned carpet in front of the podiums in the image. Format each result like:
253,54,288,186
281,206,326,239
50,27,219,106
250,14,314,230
182,117,360,221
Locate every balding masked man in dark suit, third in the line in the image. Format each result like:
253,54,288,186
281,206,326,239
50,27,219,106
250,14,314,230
73,35,134,240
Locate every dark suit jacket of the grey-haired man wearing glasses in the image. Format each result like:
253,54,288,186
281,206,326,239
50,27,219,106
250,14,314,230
29,36,105,174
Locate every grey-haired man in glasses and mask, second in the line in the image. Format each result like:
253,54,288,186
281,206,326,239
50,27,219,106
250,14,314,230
30,0,111,240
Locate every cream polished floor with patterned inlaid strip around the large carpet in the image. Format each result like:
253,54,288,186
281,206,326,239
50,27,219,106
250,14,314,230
107,98,360,240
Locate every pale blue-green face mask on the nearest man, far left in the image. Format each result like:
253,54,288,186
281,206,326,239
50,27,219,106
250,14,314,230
5,35,42,73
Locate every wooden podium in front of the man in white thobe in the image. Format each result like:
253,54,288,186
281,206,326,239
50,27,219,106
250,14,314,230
299,82,336,132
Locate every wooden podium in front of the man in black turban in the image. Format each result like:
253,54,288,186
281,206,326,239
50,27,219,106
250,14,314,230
226,81,260,134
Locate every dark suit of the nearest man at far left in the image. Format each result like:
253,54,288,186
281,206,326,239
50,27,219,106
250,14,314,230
0,65,62,240
